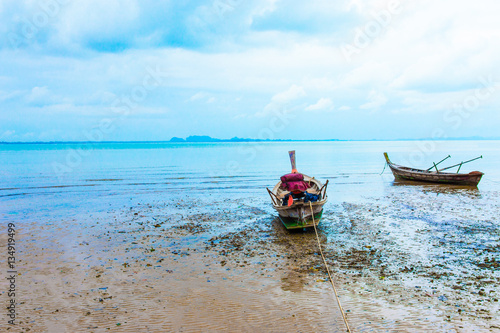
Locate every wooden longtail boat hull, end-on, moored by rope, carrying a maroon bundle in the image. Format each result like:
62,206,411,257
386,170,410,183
267,151,328,229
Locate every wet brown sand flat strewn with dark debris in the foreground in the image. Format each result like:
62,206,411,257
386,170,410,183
0,186,500,332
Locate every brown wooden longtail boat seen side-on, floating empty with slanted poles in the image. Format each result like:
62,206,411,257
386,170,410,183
384,153,484,186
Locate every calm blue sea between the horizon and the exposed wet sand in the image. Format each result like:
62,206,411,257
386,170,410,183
0,141,500,220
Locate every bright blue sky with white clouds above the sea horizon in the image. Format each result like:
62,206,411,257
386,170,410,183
0,0,500,142
